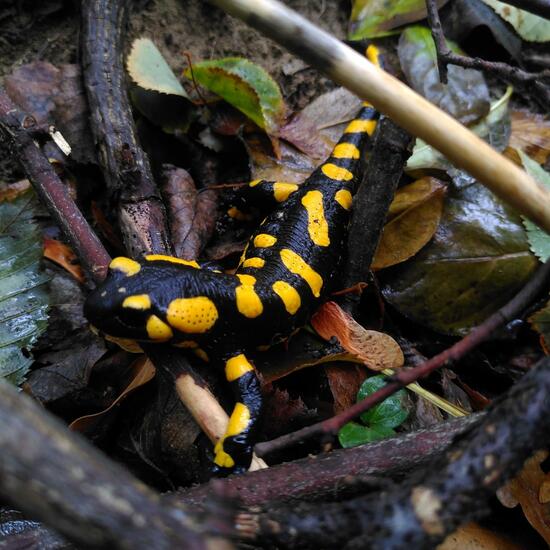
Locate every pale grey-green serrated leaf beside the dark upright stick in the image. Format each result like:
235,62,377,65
126,38,187,98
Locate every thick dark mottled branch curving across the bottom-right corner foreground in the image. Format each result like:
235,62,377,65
244,358,550,550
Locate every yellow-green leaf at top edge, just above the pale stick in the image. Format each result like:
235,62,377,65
348,0,446,40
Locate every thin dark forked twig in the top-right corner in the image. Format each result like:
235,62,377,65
426,0,550,108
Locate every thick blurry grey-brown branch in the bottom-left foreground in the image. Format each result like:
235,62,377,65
0,381,213,550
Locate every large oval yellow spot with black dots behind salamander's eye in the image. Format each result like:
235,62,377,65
166,296,218,334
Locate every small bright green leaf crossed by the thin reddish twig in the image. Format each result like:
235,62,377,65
357,375,408,429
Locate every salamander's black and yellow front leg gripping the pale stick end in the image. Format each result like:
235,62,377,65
214,353,262,474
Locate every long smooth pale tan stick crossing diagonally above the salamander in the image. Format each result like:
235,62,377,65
210,0,550,232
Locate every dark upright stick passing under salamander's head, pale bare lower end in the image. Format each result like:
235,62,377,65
82,0,265,467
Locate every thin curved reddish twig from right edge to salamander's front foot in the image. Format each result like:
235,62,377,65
255,260,550,456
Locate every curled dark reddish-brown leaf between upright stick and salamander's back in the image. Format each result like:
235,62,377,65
162,164,217,260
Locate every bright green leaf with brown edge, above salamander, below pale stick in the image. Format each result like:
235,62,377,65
184,57,286,134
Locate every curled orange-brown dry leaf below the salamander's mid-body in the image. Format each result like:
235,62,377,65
311,302,405,371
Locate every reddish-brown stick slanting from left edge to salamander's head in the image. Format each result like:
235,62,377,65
0,89,109,282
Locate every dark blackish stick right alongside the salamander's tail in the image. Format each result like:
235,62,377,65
343,117,411,315
